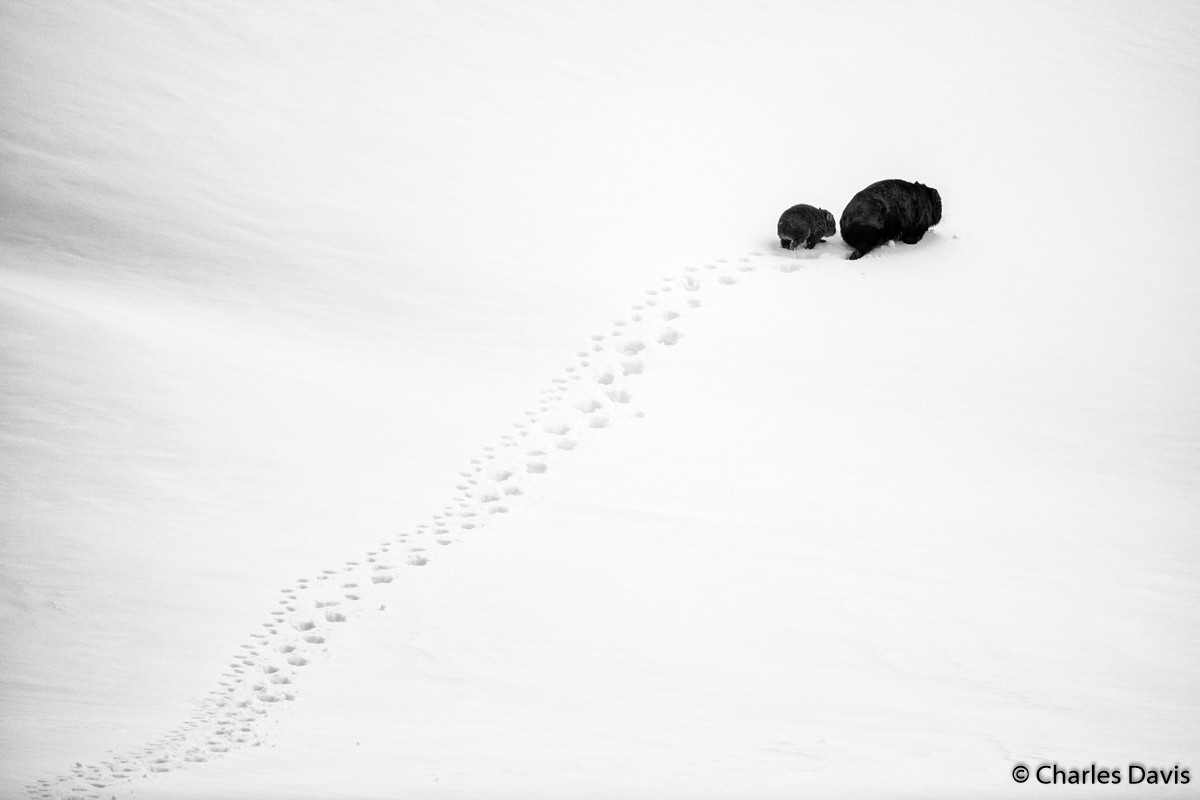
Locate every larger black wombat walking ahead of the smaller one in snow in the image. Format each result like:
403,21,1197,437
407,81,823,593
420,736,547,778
841,179,942,259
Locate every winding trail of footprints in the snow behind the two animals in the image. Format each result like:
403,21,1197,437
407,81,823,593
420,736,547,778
28,247,811,800
